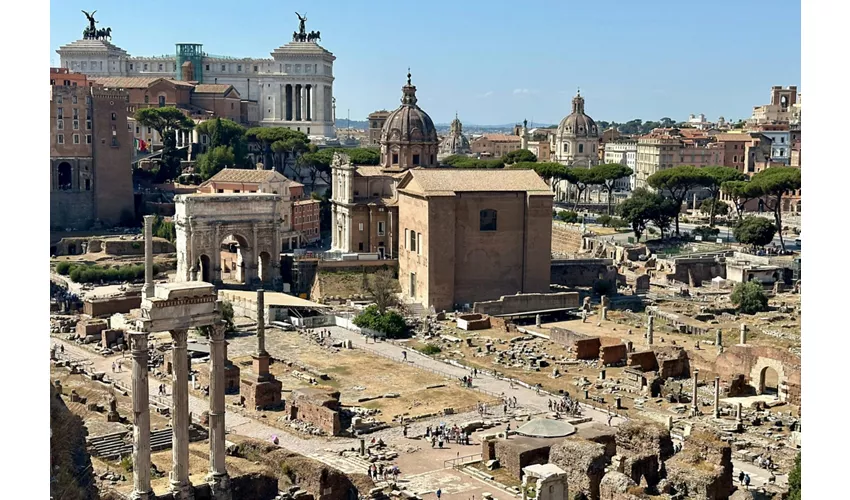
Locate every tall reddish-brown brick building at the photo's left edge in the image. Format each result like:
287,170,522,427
50,68,134,229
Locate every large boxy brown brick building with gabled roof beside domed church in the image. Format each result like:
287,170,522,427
398,169,553,310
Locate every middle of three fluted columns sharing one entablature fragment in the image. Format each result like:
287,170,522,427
171,330,194,500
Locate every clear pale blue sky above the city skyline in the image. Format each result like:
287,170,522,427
50,0,805,124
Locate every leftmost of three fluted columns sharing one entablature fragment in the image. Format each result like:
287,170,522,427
130,332,154,500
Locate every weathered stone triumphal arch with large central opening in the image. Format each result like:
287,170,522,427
174,193,284,290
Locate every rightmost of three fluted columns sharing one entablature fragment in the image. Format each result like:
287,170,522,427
206,324,230,500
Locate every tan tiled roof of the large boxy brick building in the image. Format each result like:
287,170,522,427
399,168,553,195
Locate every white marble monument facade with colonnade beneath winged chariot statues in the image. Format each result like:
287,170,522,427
56,40,336,138
